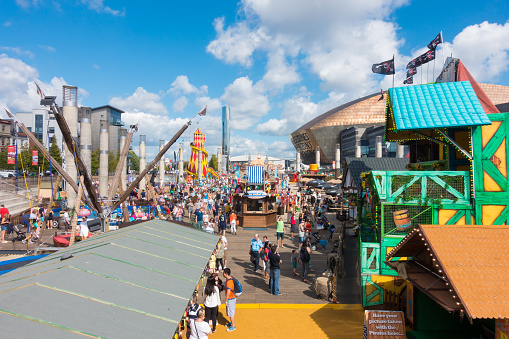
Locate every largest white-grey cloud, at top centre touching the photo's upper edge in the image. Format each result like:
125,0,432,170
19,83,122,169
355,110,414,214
207,0,408,98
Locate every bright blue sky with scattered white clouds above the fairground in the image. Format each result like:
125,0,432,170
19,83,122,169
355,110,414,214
0,0,509,161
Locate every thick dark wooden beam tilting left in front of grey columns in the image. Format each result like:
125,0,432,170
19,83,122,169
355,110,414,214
50,107,102,214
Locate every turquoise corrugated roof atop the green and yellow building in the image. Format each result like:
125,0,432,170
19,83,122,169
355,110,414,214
389,81,491,130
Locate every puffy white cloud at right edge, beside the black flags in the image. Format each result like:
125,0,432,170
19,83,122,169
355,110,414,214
437,21,509,81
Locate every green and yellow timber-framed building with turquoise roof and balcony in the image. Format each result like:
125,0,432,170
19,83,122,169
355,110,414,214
358,77,509,318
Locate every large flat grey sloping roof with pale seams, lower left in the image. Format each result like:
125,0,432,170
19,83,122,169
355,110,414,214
0,220,218,338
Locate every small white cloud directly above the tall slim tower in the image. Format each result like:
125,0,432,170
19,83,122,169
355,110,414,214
220,77,270,130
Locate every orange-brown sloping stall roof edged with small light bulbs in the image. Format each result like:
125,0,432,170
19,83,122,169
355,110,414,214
386,225,509,320
